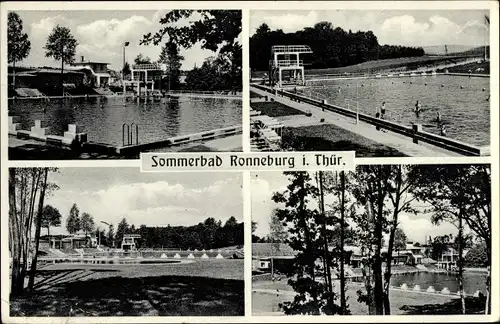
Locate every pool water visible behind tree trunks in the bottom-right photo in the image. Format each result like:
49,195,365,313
391,271,486,294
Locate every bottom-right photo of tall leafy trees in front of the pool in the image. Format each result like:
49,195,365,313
251,164,492,316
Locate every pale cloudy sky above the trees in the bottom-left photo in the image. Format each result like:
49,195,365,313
42,167,243,234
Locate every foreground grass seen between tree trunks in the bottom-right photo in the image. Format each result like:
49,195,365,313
252,281,484,315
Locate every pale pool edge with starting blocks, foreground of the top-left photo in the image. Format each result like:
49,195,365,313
8,116,243,156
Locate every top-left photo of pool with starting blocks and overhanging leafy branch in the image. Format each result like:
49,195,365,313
4,10,242,160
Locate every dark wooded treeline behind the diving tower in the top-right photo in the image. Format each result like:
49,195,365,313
250,21,424,71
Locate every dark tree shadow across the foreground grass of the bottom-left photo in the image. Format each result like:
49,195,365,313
10,271,245,316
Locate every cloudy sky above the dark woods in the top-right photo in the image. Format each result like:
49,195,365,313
250,10,487,46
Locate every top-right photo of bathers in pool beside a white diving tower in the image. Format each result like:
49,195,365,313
249,9,490,157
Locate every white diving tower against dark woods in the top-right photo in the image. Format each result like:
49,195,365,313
269,45,312,88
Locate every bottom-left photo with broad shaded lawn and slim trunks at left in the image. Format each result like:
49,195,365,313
6,167,245,316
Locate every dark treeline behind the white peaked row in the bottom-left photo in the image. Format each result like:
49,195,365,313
114,217,244,250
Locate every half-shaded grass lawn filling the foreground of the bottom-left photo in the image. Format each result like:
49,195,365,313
10,259,245,316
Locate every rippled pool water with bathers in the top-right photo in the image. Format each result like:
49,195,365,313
300,75,490,146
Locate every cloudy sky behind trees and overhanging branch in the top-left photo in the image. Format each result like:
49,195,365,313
11,10,234,70
